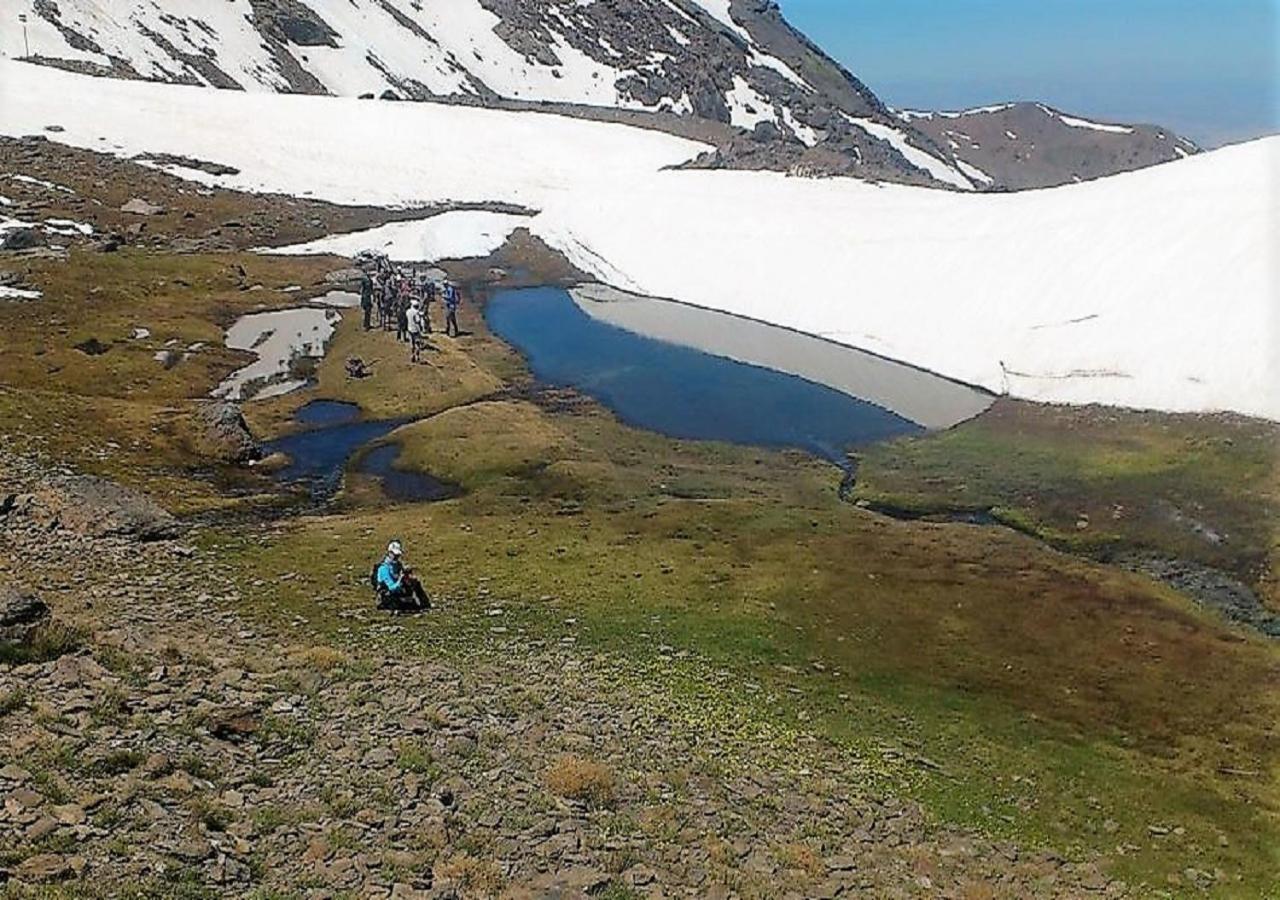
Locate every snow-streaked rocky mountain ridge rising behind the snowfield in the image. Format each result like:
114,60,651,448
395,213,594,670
0,0,1194,191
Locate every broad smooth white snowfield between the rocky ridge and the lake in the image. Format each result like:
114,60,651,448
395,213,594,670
0,61,1280,420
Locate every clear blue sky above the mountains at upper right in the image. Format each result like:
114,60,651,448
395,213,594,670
781,0,1280,146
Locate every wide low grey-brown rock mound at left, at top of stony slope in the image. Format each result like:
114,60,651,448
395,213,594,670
28,475,180,540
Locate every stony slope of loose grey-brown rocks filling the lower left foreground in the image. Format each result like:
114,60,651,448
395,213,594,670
0,456,1125,897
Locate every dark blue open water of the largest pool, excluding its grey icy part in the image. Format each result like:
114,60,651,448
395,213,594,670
485,288,923,465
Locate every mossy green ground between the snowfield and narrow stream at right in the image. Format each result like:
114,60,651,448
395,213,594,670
854,399,1280,609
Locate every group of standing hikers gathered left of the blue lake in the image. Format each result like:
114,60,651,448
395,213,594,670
357,253,462,362
